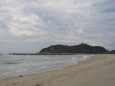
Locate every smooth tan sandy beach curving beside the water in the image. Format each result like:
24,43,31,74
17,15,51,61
0,54,115,86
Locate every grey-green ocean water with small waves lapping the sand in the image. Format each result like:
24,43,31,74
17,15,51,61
0,55,91,79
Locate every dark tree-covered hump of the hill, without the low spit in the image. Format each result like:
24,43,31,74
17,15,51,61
39,43,109,54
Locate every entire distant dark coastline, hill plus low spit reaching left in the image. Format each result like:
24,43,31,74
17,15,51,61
9,43,115,55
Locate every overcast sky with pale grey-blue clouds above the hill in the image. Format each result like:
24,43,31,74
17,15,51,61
0,0,115,53
